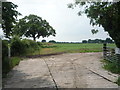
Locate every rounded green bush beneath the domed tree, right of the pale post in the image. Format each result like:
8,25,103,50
11,36,40,56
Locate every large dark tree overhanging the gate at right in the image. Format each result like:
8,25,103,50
68,0,120,48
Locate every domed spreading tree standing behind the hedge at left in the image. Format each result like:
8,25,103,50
13,14,56,40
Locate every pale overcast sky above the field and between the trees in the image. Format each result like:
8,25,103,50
2,0,109,42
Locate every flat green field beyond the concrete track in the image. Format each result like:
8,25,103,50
34,43,115,55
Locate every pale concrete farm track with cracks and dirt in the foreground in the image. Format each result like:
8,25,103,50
4,53,118,89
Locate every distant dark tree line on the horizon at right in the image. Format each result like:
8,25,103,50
82,38,114,43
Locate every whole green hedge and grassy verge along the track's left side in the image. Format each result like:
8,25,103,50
2,37,41,77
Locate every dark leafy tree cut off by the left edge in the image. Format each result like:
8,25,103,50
2,2,21,38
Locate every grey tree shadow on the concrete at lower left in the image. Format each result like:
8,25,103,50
3,70,55,88
